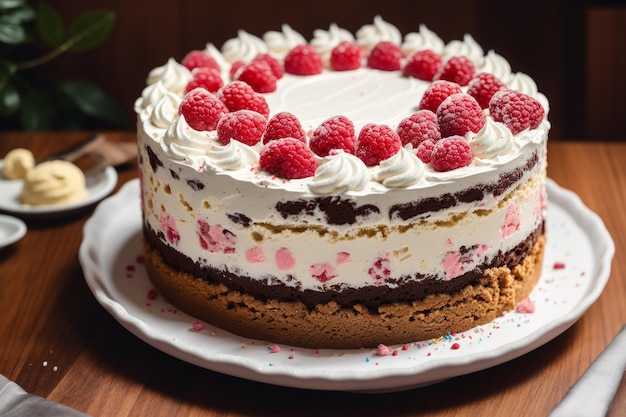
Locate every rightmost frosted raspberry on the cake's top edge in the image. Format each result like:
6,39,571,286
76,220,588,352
489,89,545,134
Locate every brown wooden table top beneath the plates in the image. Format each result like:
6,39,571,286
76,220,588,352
0,132,626,417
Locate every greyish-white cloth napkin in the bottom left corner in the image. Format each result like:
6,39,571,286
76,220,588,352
0,374,89,417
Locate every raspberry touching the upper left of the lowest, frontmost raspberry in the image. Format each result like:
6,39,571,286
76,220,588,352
217,110,267,146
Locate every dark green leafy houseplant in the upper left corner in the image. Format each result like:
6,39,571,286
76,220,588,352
0,0,127,130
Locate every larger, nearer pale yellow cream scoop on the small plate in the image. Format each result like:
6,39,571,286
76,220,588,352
21,160,87,206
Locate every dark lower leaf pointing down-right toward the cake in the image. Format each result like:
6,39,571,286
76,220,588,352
60,80,128,127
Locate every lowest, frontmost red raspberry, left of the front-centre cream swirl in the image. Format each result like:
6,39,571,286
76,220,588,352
259,138,317,180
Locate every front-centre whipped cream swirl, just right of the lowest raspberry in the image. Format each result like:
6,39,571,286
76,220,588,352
309,150,370,194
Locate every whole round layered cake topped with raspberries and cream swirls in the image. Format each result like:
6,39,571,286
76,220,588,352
135,16,550,349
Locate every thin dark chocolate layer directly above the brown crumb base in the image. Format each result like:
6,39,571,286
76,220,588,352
144,221,544,308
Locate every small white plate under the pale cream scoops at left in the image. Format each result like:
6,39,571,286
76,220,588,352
0,160,117,219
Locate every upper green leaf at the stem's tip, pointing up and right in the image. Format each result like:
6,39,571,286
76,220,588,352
68,11,115,52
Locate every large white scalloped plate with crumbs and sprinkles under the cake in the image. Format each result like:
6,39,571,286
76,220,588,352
79,180,615,392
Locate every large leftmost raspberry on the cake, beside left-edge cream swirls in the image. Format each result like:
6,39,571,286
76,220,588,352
178,87,228,130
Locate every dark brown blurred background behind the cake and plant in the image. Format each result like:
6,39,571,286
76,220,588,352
47,0,626,140
